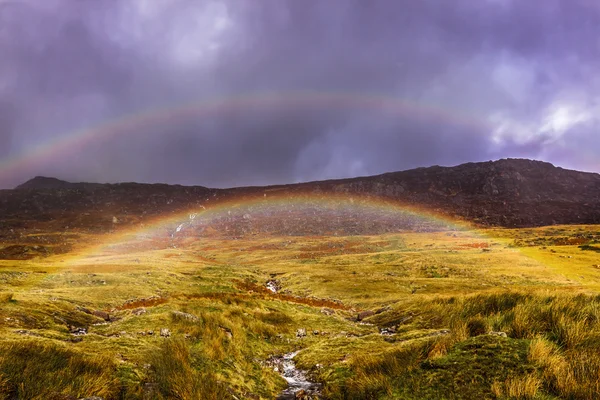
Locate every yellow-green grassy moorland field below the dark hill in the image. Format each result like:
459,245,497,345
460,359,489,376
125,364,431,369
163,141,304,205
0,226,600,399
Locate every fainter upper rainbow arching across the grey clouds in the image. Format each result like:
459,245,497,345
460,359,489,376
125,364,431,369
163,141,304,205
0,91,486,183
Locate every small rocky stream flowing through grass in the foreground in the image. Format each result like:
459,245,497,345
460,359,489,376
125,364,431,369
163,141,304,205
277,351,321,400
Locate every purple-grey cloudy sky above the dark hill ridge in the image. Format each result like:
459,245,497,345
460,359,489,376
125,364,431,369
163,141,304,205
0,0,600,187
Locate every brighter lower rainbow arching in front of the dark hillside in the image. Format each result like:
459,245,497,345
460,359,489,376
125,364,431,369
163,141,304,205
74,188,476,257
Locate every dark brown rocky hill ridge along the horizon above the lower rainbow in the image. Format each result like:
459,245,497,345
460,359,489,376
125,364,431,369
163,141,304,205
0,159,600,233
